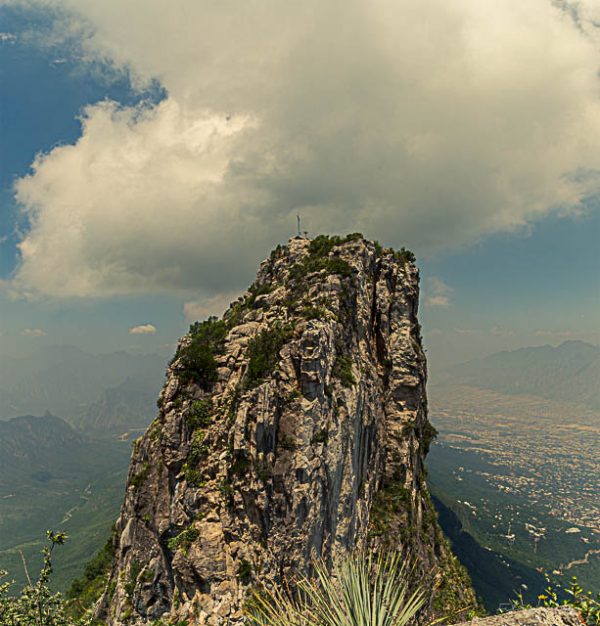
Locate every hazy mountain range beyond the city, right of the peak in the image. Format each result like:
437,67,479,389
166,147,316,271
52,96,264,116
435,341,600,409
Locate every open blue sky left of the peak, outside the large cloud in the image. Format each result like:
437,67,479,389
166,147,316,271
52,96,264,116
0,7,180,355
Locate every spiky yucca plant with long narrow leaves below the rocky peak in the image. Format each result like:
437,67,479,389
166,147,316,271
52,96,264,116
247,554,425,626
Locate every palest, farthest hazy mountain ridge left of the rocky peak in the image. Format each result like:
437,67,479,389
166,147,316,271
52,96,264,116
0,346,166,434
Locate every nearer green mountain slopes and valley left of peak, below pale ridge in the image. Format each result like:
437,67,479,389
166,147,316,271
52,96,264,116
0,414,131,589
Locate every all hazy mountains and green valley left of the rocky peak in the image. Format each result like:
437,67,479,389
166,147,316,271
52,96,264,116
0,347,166,589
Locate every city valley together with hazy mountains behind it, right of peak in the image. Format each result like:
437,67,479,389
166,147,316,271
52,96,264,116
428,341,600,608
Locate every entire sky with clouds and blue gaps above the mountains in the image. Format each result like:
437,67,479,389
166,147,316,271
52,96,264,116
0,0,600,368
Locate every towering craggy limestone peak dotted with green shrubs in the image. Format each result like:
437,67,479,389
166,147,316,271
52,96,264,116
101,236,474,624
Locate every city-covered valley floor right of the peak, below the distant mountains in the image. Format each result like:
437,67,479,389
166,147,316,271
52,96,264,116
428,387,600,608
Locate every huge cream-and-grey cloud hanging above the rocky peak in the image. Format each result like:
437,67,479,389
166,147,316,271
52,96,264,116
13,0,600,298
